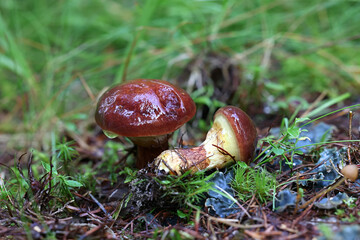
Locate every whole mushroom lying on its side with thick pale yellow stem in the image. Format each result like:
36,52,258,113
154,106,257,175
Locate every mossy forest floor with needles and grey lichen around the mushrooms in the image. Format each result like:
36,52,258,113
0,74,360,239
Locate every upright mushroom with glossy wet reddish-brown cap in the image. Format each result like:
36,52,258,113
95,79,196,169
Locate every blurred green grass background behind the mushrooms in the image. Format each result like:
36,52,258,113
0,0,360,155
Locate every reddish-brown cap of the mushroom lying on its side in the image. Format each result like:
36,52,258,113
214,106,257,163
